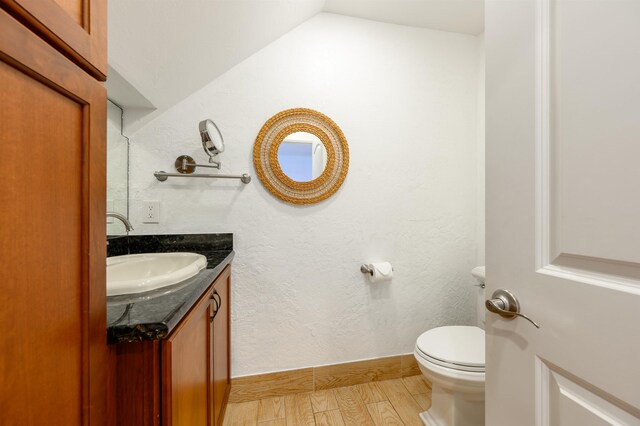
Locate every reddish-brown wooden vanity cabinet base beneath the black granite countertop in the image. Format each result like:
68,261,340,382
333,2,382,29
116,266,231,426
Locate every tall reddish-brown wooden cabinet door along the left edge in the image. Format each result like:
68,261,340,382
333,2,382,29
0,10,107,426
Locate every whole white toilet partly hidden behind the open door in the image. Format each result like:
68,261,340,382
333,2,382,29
414,266,485,426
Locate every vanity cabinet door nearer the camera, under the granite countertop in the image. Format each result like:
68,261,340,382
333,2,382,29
162,291,212,426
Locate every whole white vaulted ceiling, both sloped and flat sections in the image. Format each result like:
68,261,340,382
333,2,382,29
107,0,484,132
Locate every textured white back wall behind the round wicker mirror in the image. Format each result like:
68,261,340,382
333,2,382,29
131,14,480,376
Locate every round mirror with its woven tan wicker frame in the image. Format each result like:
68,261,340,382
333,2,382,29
253,108,349,204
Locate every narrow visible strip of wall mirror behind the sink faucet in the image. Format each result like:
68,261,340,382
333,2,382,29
107,101,129,235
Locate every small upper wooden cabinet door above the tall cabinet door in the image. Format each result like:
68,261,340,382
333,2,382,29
0,0,107,81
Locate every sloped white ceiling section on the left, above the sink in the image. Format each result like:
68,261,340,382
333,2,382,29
107,0,324,134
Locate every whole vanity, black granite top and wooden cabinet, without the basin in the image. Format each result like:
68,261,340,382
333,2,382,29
107,234,234,426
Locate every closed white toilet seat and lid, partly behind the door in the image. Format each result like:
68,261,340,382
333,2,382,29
415,326,485,373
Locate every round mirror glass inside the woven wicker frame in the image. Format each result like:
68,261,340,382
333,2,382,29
278,132,327,182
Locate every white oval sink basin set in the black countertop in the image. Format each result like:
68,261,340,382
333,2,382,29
107,253,207,296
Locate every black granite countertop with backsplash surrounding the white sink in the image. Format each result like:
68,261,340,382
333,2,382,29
107,234,235,343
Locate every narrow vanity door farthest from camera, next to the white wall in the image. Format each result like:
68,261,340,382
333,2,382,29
211,266,231,425
